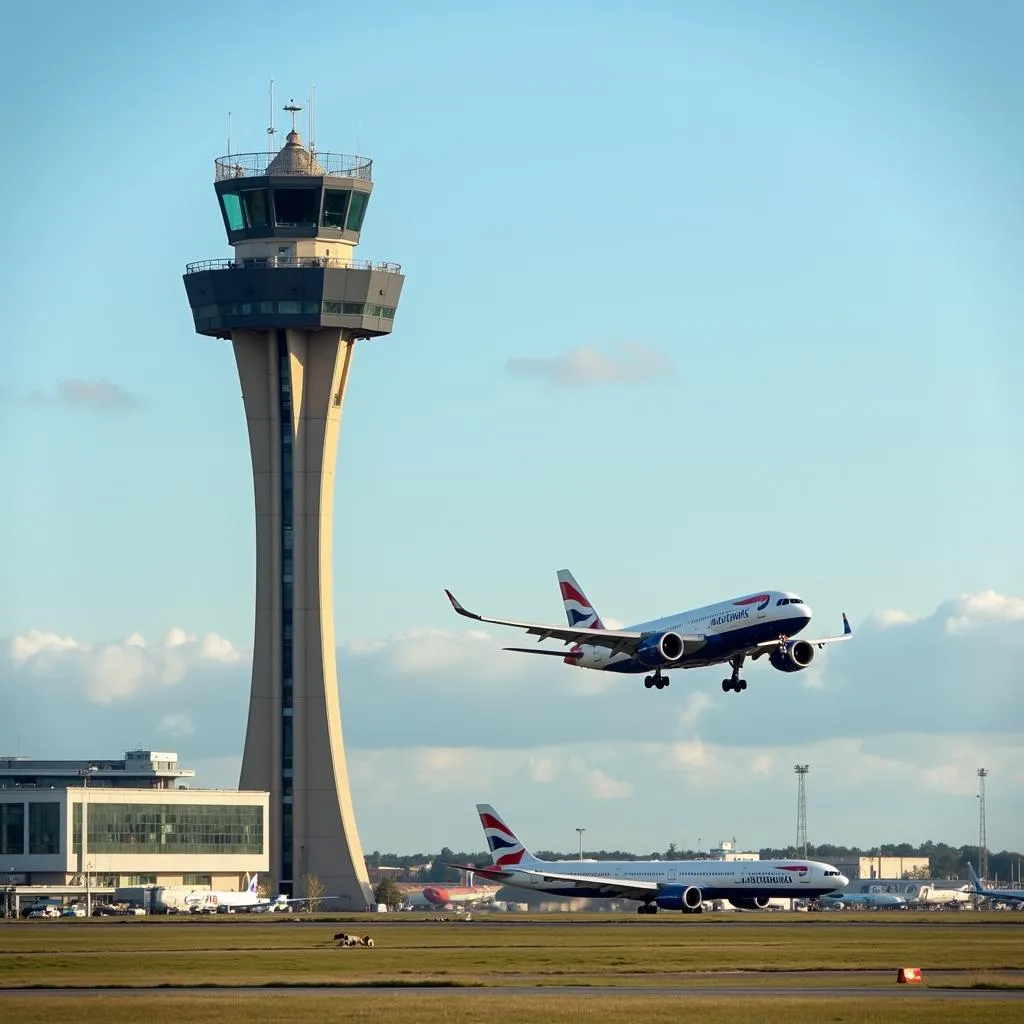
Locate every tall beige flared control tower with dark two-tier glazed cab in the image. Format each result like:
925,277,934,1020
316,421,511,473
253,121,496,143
184,106,404,909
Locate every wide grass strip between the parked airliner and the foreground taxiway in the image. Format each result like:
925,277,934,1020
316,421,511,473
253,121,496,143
0,914,1024,988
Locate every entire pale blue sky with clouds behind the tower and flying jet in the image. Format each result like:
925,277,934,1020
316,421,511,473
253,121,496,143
0,0,1024,852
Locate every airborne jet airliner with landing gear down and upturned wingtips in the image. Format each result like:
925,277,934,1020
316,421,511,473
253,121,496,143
444,569,853,693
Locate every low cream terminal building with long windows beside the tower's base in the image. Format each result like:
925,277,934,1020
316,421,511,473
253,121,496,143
0,751,269,890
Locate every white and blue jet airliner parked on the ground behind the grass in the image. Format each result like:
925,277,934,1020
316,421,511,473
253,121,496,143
449,804,849,913
